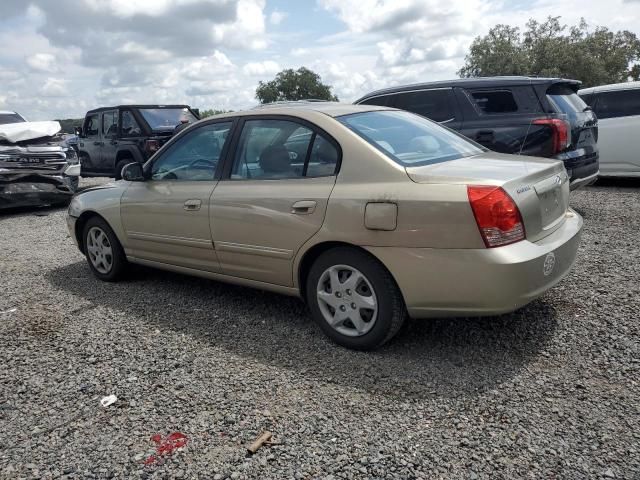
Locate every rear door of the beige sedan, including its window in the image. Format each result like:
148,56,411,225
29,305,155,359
210,117,340,286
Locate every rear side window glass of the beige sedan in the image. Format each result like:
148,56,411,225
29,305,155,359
231,119,339,180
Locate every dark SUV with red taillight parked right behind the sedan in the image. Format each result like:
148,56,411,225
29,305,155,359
355,77,599,189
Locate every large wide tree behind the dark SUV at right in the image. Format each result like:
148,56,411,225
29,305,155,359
458,17,640,87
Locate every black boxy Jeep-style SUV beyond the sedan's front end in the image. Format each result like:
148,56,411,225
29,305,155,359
76,105,198,179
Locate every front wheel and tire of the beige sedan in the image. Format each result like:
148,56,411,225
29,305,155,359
82,217,127,282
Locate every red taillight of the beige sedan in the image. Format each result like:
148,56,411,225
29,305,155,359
467,185,524,248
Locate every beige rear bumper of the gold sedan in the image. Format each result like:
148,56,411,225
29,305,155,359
367,210,582,318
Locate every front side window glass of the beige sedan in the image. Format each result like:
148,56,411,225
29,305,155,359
151,122,232,181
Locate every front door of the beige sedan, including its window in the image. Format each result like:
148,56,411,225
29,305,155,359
120,120,233,272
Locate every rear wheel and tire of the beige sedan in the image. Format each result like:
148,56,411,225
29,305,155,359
306,247,407,350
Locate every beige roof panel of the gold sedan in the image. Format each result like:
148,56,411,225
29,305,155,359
205,100,392,120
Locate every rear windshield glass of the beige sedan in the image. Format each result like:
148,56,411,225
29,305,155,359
337,110,484,167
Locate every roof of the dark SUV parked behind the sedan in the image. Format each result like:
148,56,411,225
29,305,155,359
355,76,582,103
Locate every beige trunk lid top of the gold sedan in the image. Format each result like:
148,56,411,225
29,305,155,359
407,152,563,185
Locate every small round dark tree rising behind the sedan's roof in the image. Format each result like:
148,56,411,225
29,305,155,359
256,67,338,103
